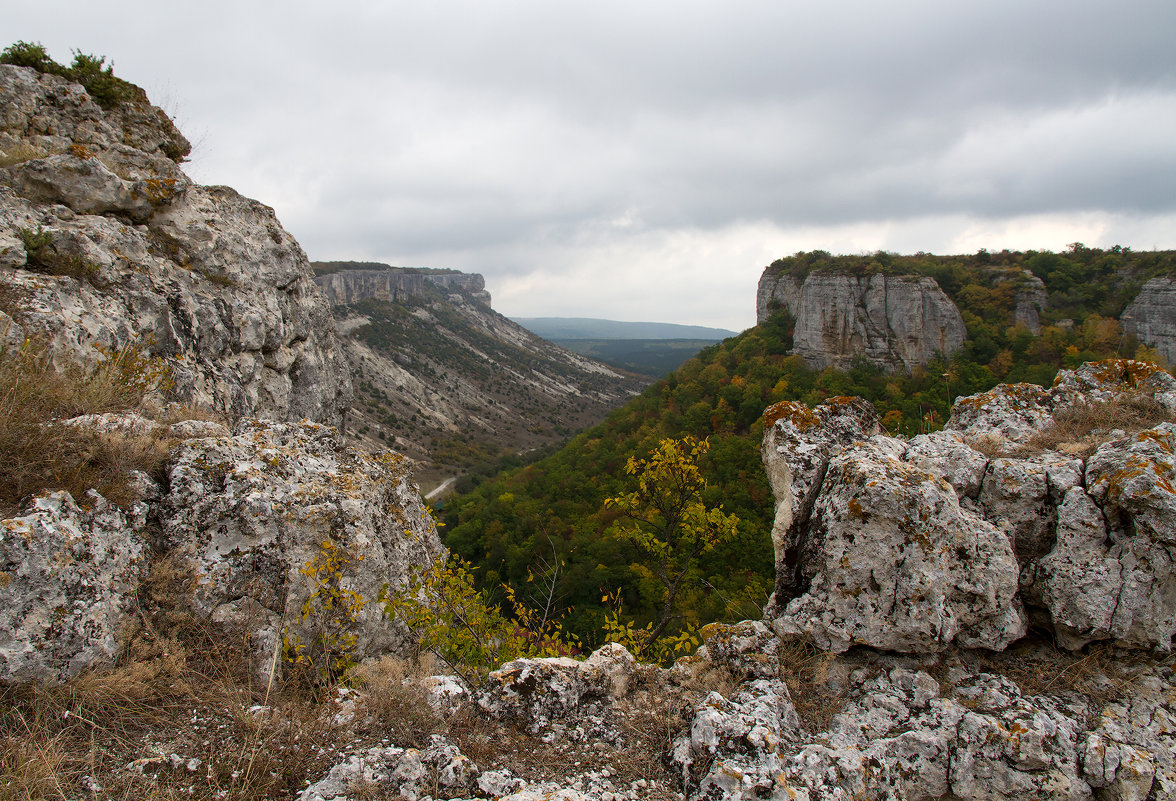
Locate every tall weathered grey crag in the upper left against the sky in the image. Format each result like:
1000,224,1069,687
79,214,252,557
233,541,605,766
0,65,352,425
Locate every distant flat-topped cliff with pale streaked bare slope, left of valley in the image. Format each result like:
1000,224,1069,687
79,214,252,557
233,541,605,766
326,274,647,485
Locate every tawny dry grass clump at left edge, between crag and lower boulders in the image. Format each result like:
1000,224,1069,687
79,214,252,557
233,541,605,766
0,342,168,514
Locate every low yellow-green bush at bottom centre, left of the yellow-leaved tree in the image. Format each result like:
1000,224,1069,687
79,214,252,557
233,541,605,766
380,555,577,687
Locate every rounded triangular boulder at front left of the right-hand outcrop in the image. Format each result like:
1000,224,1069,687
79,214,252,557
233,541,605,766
776,438,1025,653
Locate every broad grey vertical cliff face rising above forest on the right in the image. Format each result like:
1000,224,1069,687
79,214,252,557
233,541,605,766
756,269,967,371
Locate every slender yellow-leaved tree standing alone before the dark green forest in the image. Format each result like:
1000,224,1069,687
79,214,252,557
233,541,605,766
604,436,739,661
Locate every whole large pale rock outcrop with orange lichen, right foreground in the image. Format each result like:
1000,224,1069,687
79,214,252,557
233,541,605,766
763,361,1176,653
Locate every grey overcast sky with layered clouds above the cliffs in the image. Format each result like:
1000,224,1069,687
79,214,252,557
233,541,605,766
9,0,1176,329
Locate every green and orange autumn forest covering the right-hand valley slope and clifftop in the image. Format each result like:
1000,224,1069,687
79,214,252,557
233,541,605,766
445,246,1176,646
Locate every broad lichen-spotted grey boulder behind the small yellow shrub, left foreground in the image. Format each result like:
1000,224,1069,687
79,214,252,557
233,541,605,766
160,420,441,667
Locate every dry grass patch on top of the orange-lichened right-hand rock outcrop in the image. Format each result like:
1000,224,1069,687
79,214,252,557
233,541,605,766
1016,393,1171,459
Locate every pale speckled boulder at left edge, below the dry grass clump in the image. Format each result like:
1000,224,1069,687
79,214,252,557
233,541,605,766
0,492,147,681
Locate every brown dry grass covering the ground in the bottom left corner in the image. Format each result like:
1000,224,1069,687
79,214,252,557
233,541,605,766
0,560,362,801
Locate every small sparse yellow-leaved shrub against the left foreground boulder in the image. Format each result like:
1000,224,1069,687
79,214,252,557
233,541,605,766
282,540,367,687
